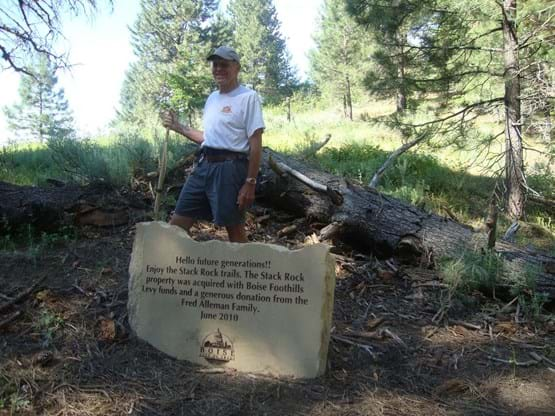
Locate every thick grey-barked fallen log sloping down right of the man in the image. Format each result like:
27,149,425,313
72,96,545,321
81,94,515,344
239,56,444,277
259,149,555,299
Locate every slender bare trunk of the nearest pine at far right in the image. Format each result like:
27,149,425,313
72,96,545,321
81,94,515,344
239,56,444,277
503,0,525,220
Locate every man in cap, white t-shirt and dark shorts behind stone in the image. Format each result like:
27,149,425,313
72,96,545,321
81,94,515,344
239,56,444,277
162,46,265,243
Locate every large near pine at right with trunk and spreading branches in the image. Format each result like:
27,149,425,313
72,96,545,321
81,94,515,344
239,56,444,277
347,0,555,220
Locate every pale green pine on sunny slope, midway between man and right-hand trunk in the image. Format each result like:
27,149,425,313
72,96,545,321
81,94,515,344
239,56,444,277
310,0,371,120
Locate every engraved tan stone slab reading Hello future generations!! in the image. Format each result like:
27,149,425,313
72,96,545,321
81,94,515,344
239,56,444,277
128,222,335,378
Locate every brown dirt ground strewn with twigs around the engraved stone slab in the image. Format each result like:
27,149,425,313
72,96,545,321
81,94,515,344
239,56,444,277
0,213,555,416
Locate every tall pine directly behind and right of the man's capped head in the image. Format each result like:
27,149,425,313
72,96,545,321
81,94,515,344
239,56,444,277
229,0,297,102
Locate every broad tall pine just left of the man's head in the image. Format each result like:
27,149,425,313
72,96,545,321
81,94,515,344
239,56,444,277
119,0,224,123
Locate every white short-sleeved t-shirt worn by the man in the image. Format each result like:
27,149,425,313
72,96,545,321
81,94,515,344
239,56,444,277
202,85,265,153
